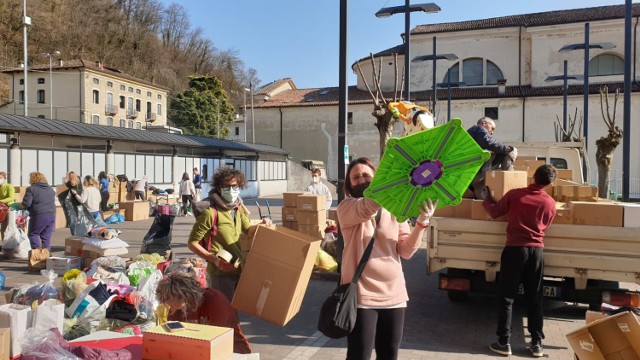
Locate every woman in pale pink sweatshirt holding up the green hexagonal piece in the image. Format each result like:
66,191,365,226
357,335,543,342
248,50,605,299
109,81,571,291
338,158,437,360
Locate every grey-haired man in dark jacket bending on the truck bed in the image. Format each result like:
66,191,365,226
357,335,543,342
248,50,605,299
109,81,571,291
467,116,518,199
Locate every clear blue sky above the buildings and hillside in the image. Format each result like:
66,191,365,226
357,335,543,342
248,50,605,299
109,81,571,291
160,0,640,89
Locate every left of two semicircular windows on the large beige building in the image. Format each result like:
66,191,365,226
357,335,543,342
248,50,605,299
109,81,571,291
442,58,504,86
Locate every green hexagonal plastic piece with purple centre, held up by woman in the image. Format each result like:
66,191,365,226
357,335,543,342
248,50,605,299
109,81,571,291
365,118,491,222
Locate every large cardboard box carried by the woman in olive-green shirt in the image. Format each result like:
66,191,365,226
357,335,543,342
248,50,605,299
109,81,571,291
231,227,321,326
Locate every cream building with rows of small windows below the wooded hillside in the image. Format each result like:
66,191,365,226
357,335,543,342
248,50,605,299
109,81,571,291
0,60,168,129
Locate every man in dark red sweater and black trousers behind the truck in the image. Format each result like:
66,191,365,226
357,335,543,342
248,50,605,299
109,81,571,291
482,164,556,357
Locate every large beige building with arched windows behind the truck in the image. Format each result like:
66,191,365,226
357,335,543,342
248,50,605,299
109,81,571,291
249,4,640,196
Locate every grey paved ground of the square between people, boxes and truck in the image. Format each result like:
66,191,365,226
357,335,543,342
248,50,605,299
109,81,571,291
0,199,586,360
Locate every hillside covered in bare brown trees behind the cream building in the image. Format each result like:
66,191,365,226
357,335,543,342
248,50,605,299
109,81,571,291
0,0,260,133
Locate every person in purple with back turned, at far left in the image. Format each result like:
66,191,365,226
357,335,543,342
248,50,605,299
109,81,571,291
22,172,56,251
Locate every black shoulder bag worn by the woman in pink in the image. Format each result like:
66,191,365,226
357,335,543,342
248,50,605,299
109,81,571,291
318,209,382,339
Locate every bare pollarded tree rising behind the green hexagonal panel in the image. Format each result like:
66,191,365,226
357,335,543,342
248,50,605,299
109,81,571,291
356,53,405,157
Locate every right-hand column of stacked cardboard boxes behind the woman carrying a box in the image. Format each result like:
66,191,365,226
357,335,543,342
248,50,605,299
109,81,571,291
296,194,327,239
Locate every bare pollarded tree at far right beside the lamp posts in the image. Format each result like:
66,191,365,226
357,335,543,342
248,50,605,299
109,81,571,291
596,86,623,198
